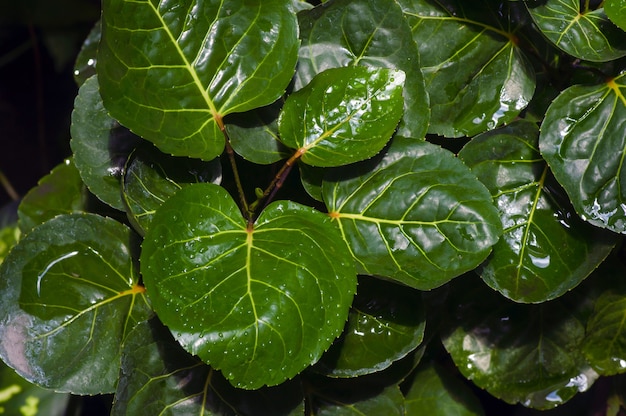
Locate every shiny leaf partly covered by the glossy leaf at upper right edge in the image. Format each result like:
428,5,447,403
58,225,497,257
459,121,616,303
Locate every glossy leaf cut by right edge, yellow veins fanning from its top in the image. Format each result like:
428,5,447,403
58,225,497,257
539,75,626,233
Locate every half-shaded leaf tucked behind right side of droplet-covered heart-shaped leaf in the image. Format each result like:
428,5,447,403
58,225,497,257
313,276,426,377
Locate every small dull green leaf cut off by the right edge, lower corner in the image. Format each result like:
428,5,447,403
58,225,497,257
583,288,626,375
